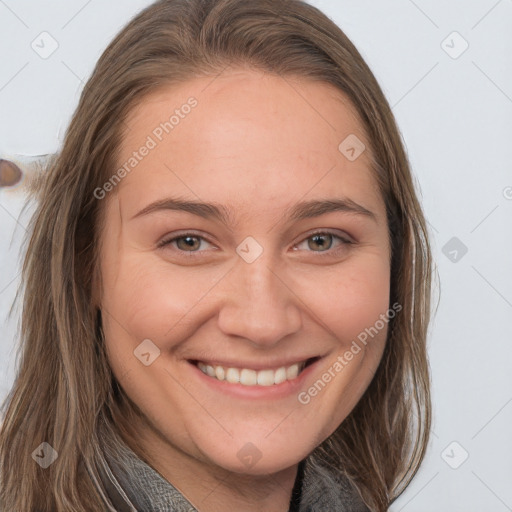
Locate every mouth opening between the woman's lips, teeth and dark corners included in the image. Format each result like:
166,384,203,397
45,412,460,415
192,357,318,386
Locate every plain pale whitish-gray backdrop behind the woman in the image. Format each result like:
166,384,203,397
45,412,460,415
0,0,512,512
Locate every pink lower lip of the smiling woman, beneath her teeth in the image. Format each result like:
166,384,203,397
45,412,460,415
189,358,323,399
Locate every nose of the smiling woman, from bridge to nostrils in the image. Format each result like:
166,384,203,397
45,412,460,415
218,255,302,348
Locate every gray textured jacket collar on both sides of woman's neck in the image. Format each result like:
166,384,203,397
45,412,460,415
94,428,371,512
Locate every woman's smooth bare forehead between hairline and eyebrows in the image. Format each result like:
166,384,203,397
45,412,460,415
112,70,379,222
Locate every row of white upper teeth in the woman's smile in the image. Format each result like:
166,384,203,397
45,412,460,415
197,362,306,386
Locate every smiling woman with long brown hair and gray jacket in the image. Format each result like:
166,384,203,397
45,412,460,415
0,0,432,512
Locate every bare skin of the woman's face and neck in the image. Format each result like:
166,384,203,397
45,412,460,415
99,68,390,512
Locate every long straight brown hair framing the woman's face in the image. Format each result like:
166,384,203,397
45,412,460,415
0,0,433,512
